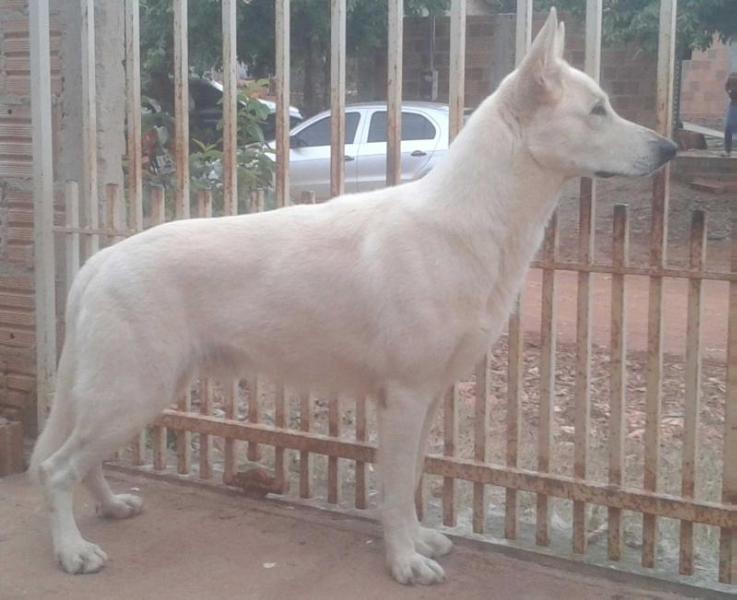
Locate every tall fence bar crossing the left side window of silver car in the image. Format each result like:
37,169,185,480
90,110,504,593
330,0,346,197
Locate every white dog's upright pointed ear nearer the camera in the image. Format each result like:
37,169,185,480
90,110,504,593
513,8,565,115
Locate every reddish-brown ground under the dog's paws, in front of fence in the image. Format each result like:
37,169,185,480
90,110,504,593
0,474,720,600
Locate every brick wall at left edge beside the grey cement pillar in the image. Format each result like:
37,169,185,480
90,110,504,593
0,0,61,434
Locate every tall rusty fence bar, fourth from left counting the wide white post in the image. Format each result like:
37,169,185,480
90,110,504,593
173,0,189,219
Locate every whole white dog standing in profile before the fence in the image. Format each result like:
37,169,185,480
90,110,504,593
31,11,672,583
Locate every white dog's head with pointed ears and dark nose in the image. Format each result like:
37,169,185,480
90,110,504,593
503,8,677,177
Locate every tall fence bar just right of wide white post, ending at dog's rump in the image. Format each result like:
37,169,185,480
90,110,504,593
81,0,100,260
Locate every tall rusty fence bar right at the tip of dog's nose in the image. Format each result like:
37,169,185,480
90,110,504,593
642,0,677,567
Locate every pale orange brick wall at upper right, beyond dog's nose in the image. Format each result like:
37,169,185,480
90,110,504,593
681,40,730,129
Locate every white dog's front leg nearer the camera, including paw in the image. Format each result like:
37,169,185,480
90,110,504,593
379,388,445,584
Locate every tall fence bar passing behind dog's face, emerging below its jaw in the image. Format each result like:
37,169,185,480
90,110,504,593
573,0,602,554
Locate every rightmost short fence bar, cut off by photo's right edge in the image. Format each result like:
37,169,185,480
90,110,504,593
719,205,737,584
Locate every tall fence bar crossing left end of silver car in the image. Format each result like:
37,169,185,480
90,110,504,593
276,0,290,207
